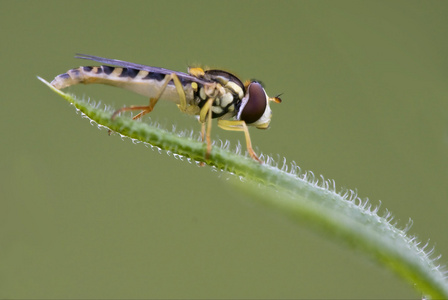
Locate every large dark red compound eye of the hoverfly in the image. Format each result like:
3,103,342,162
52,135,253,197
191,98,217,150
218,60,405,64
240,82,267,124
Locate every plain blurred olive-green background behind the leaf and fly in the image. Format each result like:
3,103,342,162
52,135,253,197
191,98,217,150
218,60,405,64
0,1,448,299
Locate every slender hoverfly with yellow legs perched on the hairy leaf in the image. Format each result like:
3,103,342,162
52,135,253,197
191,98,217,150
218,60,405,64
51,54,281,162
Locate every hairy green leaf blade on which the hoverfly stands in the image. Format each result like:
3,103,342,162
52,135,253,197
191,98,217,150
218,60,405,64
39,78,448,299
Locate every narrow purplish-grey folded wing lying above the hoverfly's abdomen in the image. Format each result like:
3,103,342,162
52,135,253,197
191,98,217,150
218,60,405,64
75,53,210,84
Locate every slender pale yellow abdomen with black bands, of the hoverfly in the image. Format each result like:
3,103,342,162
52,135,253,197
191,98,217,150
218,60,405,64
51,66,193,103
